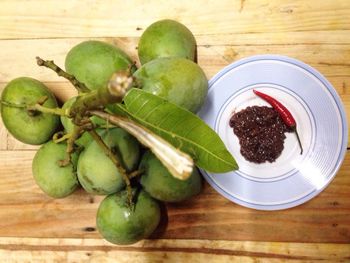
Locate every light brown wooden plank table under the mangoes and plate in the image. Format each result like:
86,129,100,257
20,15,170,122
0,0,350,262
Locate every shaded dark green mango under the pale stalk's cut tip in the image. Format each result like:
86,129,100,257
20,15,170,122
140,152,202,202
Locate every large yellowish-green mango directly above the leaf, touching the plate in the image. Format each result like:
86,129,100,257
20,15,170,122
134,57,208,112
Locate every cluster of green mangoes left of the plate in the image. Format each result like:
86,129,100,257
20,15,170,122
1,20,208,244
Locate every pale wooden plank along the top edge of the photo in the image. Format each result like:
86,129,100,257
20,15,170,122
0,0,350,39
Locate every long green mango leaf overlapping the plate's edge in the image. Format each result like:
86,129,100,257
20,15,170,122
109,89,238,173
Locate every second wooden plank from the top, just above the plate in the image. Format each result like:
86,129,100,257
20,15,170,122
0,37,350,82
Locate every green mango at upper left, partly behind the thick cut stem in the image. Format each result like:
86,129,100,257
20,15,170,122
65,40,134,90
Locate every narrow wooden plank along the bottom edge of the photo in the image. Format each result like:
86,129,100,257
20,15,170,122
0,238,350,262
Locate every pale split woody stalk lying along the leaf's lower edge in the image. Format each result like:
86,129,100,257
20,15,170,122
90,111,194,180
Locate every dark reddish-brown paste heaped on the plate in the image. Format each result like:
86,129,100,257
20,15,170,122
230,106,293,163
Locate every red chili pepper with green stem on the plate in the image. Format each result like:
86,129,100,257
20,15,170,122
253,89,303,154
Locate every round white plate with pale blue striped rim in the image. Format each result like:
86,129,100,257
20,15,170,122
199,55,348,210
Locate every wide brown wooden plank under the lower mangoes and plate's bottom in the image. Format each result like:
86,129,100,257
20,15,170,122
0,151,350,243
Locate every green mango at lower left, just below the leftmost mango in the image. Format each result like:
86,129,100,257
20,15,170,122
32,141,79,198
